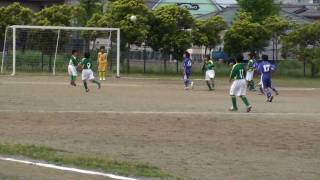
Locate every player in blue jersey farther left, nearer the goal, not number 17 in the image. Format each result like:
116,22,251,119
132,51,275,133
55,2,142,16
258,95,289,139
183,51,193,90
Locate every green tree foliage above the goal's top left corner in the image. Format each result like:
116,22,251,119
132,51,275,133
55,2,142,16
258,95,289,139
0,2,34,39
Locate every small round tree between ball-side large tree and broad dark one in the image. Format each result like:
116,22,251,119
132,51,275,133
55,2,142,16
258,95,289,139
192,16,227,54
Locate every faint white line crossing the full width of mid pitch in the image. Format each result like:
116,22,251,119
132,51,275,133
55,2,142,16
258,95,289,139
0,109,320,116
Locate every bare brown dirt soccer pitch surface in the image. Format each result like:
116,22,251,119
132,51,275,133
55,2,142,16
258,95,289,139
0,76,320,180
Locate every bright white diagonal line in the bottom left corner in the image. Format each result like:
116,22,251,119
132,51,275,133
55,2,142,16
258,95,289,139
0,156,137,180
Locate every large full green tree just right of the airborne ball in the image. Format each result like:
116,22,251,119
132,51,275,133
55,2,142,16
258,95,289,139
149,5,194,72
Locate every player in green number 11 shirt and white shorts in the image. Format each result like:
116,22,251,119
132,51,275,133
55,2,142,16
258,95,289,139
229,54,252,112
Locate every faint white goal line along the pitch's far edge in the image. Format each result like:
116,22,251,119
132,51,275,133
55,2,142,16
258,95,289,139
0,78,320,91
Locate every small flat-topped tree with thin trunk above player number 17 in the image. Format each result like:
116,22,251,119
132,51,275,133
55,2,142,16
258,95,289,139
262,16,290,60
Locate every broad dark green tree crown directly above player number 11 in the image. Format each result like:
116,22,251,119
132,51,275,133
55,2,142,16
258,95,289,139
224,13,270,55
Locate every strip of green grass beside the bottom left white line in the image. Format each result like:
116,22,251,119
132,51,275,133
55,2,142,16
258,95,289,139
0,144,176,179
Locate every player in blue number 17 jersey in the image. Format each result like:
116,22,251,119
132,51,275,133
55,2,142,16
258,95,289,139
258,55,276,102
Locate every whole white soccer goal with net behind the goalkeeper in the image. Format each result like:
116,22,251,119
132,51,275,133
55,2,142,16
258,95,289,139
1,25,120,77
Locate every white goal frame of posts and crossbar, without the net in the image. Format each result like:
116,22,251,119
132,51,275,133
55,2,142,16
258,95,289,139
1,25,120,77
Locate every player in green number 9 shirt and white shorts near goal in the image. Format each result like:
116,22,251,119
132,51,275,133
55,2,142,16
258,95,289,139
80,52,101,92
